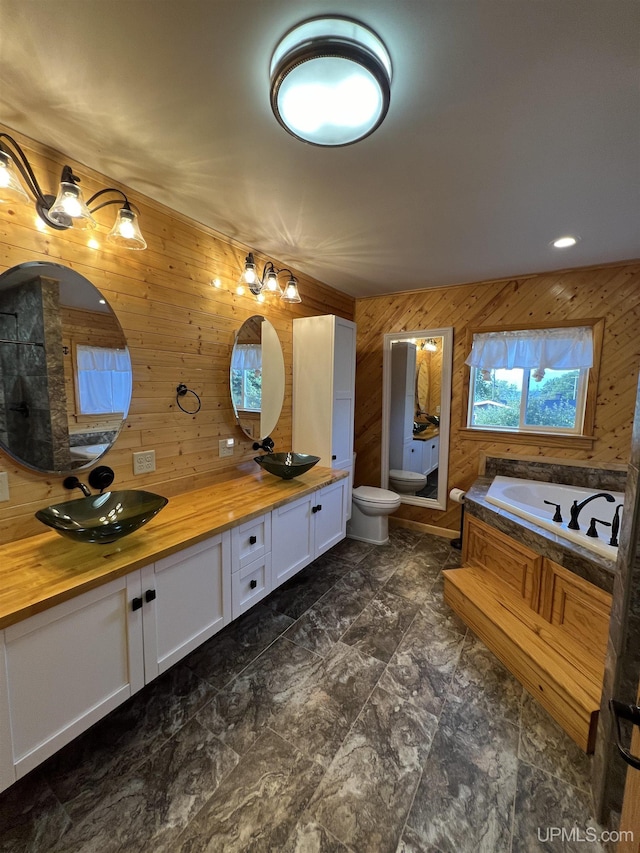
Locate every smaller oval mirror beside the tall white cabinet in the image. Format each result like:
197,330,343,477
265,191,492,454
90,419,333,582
230,314,284,441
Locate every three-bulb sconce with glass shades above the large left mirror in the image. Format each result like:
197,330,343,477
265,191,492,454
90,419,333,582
0,133,147,249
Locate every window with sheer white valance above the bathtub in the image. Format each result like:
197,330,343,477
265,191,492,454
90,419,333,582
466,326,593,434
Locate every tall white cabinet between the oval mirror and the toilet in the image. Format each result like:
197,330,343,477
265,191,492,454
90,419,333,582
293,314,356,506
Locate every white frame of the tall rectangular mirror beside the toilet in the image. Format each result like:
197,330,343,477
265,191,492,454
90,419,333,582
380,326,453,510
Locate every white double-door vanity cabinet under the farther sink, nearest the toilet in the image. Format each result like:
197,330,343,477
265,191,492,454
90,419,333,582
271,478,351,589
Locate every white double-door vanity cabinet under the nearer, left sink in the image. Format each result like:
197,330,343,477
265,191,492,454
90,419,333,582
0,531,231,787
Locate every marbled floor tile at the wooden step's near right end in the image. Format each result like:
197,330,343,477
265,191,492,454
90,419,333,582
519,692,591,791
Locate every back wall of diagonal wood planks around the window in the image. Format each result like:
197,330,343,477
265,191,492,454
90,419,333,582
355,262,640,529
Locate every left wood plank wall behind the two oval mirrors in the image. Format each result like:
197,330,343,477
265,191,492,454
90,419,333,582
0,126,355,542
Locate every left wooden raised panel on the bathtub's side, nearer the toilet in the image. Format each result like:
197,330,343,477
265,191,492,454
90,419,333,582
464,515,542,610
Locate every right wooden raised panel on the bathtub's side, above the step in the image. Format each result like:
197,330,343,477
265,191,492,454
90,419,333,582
540,557,611,662
